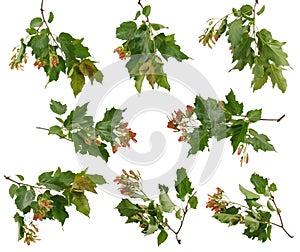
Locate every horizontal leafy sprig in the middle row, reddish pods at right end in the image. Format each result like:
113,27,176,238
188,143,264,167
48,100,137,162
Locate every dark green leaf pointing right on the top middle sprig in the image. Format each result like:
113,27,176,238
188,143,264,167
154,33,189,62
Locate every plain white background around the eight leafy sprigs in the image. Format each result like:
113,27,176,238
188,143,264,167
0,0,300,252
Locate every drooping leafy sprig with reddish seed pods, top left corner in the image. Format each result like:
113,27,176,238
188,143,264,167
10,8,103,96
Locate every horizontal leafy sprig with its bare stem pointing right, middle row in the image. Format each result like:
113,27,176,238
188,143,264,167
167,90,284,165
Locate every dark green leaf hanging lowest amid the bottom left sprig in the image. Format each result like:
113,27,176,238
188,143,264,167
51,195,69,226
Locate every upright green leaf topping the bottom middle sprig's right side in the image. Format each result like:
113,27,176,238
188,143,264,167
175,168,194,201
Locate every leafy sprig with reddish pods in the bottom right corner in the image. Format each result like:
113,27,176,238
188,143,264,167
206,173,292,242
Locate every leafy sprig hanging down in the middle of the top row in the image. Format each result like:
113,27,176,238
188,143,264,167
115,2,189,92
